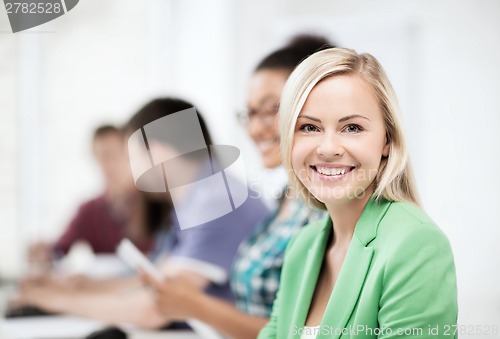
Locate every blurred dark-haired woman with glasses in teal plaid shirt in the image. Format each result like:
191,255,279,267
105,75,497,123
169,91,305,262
144,35,329,338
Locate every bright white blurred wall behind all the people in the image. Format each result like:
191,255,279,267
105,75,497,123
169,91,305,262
0,0,500,338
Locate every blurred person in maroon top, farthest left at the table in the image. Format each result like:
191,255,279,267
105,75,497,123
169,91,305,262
29,125,148,263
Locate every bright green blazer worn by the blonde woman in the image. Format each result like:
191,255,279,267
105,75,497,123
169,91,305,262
259,199,458,339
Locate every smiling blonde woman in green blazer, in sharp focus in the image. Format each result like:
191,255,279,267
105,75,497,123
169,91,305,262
259,48,457,338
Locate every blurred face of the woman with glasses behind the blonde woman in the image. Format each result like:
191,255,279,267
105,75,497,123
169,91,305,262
247,69,290,168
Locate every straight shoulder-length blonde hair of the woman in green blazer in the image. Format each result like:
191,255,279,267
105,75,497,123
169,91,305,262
279,48,418,209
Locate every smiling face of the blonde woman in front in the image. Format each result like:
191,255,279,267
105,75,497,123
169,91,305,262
292,75,390,207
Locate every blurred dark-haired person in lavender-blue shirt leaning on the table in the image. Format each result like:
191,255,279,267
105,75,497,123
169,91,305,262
16,98,268,328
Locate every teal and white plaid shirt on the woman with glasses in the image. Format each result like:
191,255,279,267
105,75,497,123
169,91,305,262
231,198,325,317
